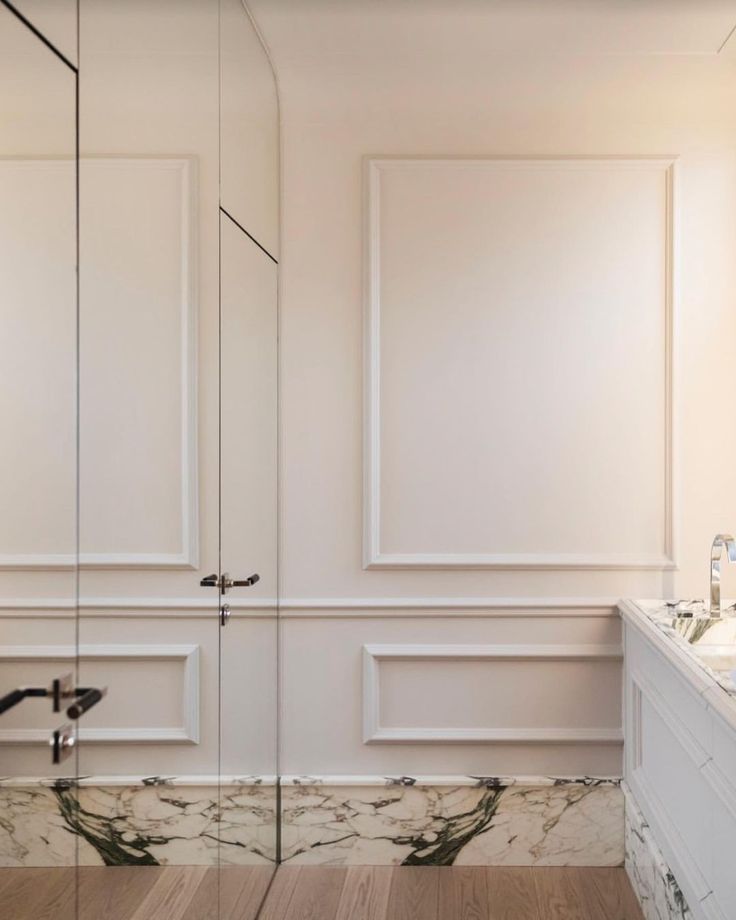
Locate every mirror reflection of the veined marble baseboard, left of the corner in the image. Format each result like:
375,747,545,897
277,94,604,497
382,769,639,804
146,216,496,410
0,777,277,866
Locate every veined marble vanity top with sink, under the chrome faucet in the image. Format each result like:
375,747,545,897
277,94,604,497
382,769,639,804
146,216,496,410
621,600,736,703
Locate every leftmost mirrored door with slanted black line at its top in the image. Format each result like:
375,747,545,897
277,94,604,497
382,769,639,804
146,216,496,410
0,5,77,920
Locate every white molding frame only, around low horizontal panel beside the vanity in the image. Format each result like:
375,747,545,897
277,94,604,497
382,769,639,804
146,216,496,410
363,644,623,744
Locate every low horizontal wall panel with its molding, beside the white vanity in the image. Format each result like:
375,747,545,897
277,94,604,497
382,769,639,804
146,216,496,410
363,644,623,745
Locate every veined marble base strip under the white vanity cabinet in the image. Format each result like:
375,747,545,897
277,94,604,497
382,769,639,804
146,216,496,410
624,789,692,920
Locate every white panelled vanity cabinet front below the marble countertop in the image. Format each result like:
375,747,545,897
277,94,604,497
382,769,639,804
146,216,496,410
621,602,736,920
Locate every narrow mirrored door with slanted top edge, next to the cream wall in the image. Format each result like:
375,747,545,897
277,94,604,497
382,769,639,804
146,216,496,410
219,214,278,917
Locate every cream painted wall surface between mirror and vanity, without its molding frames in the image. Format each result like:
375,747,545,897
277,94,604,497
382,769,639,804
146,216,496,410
262,16,736,773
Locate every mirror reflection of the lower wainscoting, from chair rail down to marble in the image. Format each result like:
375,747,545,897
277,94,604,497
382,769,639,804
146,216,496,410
0,608,276,779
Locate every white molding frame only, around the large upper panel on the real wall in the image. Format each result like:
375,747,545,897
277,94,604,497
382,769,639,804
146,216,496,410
363,155,678,571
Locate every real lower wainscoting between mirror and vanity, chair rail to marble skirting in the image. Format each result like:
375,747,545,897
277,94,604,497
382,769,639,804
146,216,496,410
281,599,622,776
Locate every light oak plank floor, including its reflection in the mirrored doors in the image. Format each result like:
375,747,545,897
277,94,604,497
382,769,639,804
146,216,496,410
0,866,642,920
